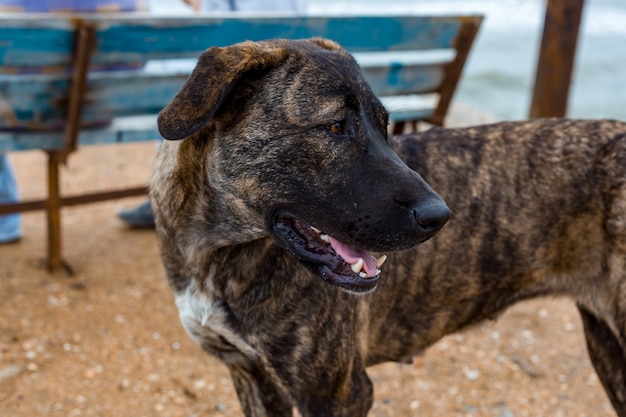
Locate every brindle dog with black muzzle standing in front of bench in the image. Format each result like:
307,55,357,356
151,39,626,417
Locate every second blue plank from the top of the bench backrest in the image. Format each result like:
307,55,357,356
0,61,445,128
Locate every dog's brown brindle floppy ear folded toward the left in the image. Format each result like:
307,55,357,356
158,42,287,140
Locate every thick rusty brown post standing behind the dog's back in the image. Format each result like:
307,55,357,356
530,0,585,117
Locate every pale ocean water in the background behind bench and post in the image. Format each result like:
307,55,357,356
151,0,626,120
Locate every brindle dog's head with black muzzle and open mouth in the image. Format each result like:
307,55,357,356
156,39,450,292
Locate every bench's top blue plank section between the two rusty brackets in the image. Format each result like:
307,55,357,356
95,15,459,57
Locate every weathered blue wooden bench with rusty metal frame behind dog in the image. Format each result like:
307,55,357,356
0,14,482,270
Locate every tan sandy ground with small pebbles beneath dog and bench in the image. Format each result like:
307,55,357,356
0,106,615,417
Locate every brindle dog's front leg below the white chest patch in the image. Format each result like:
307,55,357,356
228,364,293,417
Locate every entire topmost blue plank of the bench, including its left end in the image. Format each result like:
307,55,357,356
0,14,480,66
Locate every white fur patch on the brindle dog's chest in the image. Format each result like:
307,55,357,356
175,279,258,362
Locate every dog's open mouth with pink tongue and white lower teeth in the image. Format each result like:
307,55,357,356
274,217,387,292
